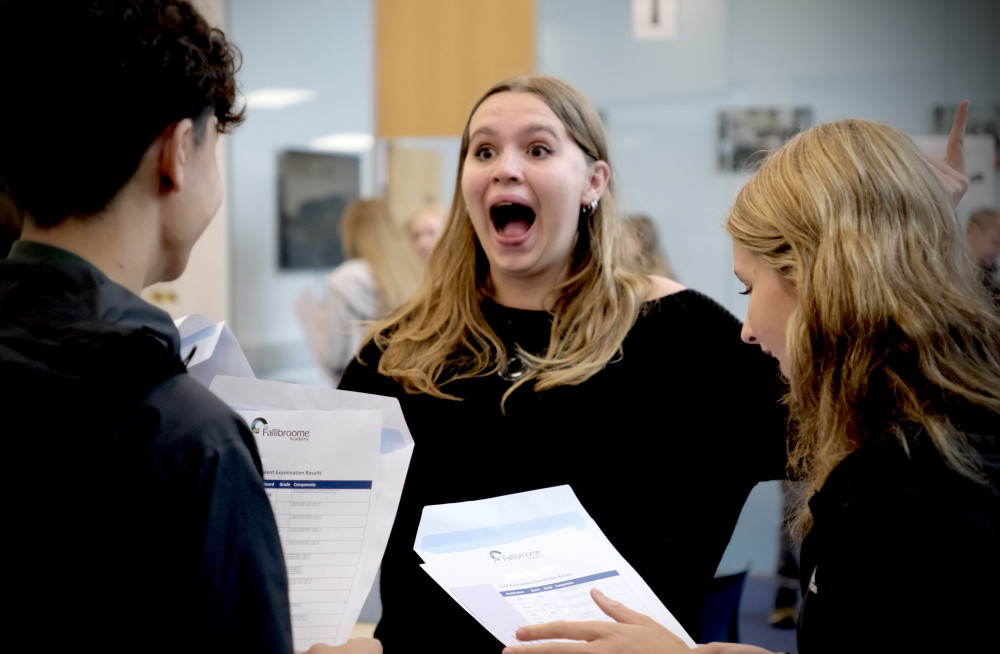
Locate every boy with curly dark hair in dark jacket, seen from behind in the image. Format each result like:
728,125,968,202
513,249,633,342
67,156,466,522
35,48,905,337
0,0,381,654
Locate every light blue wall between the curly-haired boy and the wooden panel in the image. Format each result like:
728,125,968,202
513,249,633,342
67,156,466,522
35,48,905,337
226,0,375,376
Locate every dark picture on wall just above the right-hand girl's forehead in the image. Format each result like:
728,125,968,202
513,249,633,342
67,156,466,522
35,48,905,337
719,107,812,171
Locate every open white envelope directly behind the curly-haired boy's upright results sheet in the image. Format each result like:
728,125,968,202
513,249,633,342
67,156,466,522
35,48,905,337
209,375,413,649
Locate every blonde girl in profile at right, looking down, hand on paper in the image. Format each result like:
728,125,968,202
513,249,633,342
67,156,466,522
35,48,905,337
511,103,1000,654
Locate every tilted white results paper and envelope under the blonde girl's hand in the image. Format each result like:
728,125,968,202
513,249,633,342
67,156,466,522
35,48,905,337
413,486,695,647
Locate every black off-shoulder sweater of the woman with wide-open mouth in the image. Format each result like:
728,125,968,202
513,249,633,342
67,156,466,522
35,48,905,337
340,291,786,654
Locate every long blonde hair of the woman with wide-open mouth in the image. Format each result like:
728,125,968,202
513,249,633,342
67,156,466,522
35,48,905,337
366,76,650,403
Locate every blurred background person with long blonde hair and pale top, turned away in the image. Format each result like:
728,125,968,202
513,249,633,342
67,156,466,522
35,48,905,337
318,199,420,385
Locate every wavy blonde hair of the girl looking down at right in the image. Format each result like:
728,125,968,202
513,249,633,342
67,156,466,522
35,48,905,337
726,120,1000,532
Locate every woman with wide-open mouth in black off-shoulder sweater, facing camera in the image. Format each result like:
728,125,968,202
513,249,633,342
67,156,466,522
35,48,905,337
340,76,785,653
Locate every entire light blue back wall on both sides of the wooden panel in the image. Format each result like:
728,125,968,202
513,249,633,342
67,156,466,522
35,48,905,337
227,0,1000,572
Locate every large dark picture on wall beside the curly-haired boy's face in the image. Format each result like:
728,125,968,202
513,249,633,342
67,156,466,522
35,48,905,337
278,152,360,269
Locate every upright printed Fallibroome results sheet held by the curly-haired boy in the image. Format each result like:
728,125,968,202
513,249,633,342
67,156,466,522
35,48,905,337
241,410,382,650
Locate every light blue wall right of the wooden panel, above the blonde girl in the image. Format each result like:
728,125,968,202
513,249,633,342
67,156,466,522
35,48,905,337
538,0,1000,315
